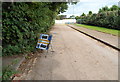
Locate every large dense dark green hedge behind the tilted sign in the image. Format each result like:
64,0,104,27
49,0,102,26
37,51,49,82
2,2,66,56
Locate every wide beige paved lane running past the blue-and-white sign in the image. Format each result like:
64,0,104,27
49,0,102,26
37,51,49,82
14,24,118,80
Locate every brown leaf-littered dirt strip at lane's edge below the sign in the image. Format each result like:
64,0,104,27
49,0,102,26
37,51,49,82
12,50,43,80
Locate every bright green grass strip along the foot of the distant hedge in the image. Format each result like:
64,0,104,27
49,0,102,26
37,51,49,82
75,24,120,36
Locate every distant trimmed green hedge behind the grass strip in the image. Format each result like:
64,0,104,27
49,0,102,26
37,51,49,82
76,5,120,30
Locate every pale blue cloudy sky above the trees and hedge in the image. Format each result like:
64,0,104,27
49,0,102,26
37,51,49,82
60,0,120,17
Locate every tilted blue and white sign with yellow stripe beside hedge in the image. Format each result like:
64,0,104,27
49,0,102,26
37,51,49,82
36,34,52,50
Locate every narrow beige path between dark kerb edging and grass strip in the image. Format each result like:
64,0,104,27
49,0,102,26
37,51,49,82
69,24,120,48
